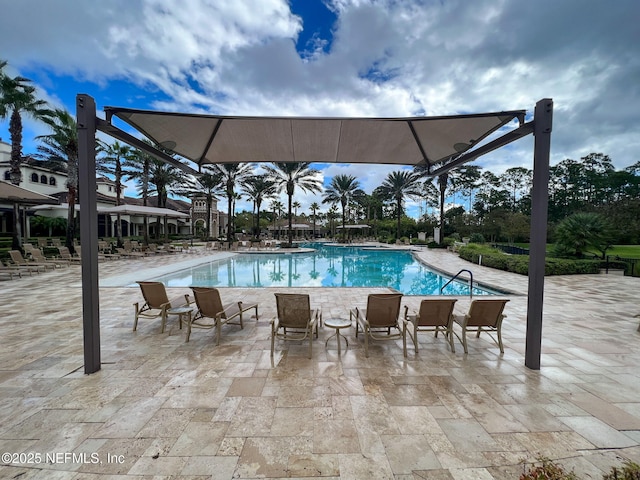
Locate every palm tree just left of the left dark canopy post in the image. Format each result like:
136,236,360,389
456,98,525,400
36,108,78,252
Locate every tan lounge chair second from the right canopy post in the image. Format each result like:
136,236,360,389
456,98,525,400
403,298,457,357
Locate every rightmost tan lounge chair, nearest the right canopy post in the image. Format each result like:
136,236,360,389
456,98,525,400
453,299,509,353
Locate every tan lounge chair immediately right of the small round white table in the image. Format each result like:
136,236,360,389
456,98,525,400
349,293,406,357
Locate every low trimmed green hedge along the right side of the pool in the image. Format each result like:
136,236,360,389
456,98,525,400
458,244,611,275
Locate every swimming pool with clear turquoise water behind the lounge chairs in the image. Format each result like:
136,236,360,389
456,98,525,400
153,243,499,295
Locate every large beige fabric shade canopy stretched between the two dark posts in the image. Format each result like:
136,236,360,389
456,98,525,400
105,107,525,167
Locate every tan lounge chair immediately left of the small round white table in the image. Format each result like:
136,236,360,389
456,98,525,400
271,293,322,358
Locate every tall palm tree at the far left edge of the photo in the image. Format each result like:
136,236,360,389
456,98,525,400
0,60,51,249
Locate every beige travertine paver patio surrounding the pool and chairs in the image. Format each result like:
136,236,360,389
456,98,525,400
0,246,640,480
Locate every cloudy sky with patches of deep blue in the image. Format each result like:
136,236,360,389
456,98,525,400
0,0,640,218
